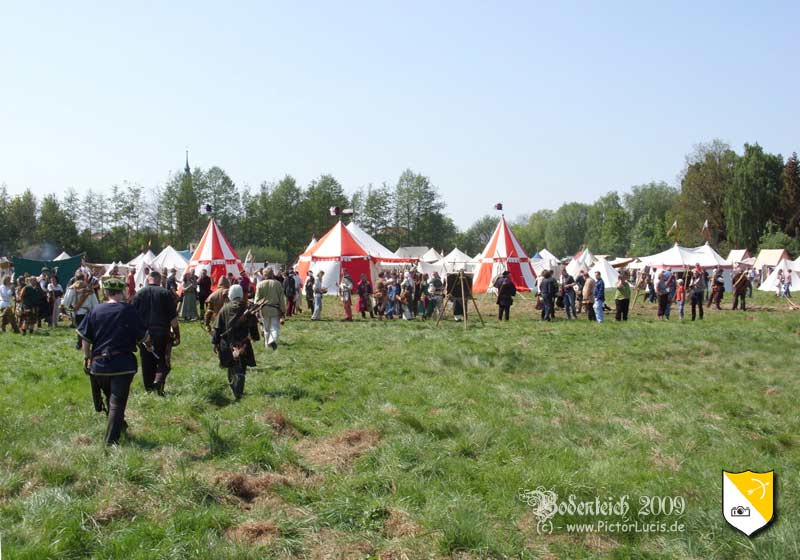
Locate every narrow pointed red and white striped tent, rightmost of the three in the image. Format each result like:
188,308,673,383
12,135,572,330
472,216,536,294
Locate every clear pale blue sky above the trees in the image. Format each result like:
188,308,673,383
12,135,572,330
0,0,800,227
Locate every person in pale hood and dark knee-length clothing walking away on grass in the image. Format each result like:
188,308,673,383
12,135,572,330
211,286,260,401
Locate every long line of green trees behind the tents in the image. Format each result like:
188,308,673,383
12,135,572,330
0,140,800,263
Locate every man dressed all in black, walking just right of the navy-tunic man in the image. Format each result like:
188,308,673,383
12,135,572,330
131,270,181,397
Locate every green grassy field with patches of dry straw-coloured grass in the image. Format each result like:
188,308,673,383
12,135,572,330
0,294,800,560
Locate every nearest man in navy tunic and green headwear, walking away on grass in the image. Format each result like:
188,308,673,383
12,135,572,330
78,276,147,445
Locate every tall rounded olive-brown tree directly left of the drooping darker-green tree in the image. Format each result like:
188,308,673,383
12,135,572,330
673,140,737,245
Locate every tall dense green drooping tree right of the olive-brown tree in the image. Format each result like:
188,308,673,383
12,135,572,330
723,144,783,249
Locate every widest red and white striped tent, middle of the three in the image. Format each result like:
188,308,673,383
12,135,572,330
297,221,411,295
